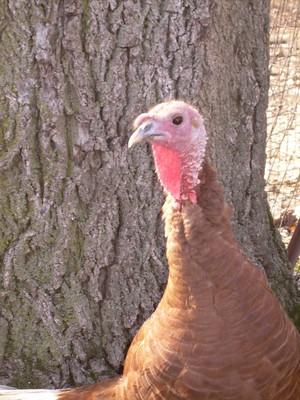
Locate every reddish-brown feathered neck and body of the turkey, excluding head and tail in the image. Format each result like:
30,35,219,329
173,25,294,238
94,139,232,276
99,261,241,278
119,162,300,400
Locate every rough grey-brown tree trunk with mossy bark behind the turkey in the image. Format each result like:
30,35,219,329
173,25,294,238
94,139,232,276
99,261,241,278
0,0,294,387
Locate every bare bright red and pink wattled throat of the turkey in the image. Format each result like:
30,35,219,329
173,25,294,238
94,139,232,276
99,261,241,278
152,130,206,210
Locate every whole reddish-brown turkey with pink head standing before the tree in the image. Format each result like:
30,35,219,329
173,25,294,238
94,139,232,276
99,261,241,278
0,101,300,400
